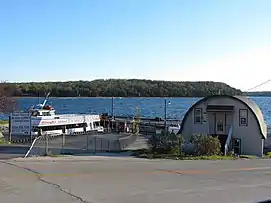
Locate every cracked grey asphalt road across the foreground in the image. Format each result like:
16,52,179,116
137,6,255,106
0,157,271,203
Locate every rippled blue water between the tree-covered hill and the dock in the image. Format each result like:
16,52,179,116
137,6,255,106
0,97,271,125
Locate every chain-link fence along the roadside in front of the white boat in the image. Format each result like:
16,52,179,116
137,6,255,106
26,132,138,157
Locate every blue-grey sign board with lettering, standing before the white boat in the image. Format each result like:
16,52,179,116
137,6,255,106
10,113,31,135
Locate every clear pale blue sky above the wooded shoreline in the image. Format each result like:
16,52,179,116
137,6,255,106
0,0,271,91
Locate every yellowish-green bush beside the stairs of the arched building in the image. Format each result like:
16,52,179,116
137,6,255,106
192,134,221,156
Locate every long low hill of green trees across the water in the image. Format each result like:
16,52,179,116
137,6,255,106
7,79,242,97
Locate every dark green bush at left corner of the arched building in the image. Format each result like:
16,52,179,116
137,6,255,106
148,133,184,155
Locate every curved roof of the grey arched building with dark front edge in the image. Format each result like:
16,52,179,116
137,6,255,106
179,95,267,139
